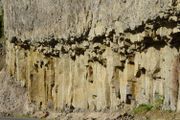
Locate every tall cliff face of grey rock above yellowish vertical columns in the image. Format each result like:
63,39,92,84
3,0,180,111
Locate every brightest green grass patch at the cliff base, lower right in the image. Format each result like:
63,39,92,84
133,104,153,114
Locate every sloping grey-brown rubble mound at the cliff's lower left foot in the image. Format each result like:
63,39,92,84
0,69,27,117
